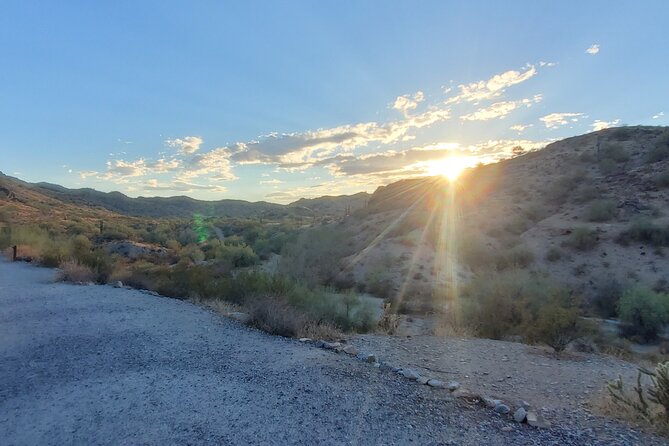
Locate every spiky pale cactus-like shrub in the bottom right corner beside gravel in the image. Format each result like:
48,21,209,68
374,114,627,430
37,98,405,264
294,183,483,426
607,361,669,434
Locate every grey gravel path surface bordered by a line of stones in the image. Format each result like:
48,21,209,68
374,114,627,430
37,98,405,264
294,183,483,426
0,262,663,445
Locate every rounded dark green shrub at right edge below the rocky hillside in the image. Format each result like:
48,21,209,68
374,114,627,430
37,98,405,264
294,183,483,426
618,288,669,342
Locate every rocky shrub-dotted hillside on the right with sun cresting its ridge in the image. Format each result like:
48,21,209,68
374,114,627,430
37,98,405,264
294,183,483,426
342,127,669,306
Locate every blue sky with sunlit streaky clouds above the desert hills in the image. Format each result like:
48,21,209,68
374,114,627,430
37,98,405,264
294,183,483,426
0,0,669,203
